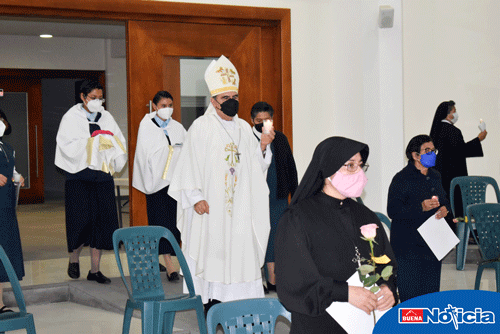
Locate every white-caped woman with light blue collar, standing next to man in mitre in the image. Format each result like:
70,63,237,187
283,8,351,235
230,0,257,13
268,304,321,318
132,91,186,281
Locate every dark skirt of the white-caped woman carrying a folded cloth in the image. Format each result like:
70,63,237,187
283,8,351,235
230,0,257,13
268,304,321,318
64,179,118,252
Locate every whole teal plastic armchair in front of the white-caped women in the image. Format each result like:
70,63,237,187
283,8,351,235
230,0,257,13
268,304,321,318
113,226,207,334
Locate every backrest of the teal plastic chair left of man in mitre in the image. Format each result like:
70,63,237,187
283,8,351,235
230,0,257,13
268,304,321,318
113,226,195,302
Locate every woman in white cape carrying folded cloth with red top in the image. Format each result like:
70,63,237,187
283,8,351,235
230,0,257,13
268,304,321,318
55,81,127,284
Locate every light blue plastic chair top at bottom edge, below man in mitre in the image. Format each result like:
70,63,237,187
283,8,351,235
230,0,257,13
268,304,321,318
207,298,292,334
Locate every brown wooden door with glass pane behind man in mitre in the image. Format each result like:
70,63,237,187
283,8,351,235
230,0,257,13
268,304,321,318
127,21,282,225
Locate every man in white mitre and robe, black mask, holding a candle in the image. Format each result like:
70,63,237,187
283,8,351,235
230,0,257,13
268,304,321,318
169,56,274,312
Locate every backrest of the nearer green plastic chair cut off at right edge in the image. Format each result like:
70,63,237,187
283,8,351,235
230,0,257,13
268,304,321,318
466,203,500,260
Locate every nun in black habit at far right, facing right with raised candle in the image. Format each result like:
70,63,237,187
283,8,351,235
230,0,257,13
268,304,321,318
430,101,487,220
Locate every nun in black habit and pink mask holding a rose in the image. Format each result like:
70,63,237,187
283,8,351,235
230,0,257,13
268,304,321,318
275,137,397,334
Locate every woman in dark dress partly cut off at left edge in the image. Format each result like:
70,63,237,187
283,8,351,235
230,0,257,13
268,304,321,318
0,110,24,313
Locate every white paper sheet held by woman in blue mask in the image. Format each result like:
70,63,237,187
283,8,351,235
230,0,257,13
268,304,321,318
417,215,460,261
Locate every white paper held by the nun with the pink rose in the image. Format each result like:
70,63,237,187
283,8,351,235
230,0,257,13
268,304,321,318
326,271,390,334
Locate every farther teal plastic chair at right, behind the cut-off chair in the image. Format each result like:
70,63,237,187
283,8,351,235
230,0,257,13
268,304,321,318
450,176,500,270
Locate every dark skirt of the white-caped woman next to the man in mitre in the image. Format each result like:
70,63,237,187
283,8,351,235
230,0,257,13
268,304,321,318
146,186,181,255
